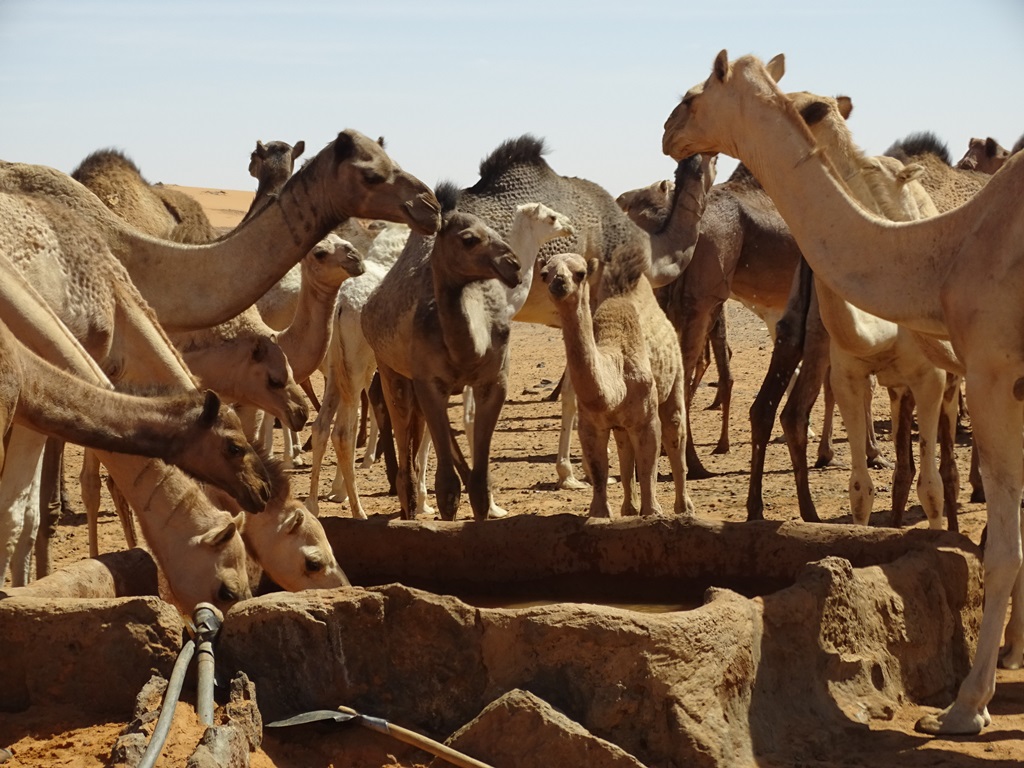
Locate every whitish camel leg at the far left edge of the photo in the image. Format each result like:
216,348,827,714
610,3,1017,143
0,426,46,587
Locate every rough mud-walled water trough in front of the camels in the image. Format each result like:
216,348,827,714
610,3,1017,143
0,515,981,767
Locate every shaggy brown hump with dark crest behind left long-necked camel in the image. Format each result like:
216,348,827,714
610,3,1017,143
71,148,217,243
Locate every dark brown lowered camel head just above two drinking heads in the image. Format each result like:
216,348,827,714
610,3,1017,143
168,390,272,512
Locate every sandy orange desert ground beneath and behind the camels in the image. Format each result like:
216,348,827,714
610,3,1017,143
0,187,1024,768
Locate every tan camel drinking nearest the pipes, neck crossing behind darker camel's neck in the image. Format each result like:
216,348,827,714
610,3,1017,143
0,268,251,615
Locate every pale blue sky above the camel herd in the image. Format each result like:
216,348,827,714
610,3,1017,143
0,0,1024,195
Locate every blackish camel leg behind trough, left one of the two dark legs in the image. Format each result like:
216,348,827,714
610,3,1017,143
746,260,814,520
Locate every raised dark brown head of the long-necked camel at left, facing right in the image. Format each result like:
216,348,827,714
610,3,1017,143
327,130,440,234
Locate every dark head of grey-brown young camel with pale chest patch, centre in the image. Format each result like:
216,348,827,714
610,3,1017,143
430,198,522,288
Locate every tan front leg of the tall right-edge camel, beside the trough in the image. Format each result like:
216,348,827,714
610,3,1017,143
916,365,1024,733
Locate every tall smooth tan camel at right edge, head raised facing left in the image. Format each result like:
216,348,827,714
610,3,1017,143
663,50,1024,734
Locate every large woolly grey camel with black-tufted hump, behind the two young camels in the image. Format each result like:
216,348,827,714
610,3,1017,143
448,134,699,488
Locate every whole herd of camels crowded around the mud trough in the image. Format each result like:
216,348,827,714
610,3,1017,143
0,51,1024,733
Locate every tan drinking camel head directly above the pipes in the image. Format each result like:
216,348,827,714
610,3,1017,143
160,512,252,615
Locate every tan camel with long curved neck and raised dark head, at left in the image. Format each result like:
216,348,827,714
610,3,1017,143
0,131,438,331
